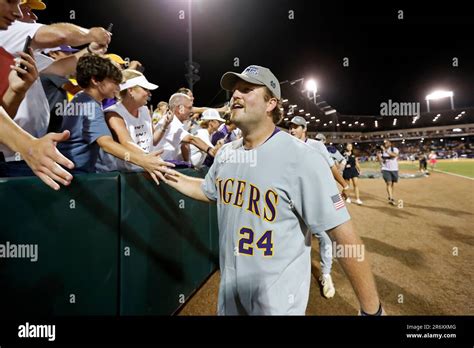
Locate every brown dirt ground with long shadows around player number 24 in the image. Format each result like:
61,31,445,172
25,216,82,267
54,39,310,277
179,173,474,315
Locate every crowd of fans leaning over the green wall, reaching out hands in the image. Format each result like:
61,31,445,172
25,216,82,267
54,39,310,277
0,0,236,190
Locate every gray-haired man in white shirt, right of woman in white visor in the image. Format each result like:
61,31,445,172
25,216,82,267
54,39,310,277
155,93,215,162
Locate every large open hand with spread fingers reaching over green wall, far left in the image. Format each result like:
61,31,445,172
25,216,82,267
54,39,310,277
20,131,74,190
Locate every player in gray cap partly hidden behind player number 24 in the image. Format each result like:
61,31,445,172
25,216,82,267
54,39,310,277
289,116,349,298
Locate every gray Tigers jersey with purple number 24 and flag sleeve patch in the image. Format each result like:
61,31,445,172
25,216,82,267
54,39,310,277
202,132,350,315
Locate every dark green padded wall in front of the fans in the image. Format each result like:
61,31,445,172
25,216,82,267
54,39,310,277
0,169,218,318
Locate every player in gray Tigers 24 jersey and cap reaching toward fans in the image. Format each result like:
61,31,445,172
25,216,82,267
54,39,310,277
166,65,382,315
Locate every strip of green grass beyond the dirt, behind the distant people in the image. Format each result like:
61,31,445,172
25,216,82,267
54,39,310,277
360,159,474,178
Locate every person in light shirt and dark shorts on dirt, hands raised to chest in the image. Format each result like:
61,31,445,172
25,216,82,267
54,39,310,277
377,140,399,205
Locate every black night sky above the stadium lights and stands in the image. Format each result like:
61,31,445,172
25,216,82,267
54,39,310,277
36,0,474,119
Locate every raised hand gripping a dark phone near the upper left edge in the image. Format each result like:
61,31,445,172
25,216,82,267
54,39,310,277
8,48,38,94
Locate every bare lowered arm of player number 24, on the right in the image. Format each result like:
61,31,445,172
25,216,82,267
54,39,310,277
327,220,386,314
